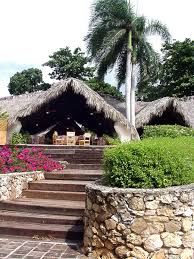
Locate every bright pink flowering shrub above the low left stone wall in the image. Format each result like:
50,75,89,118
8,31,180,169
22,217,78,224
0,146,63,173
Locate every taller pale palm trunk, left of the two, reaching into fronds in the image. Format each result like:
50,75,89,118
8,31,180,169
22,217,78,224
125,31,132,124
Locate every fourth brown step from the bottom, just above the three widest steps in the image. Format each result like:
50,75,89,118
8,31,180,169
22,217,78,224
23,190,86,201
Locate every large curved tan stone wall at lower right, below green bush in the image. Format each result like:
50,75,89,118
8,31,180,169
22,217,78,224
84,182,194,259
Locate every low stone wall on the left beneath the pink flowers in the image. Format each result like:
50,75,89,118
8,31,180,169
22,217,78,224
0,172,44,201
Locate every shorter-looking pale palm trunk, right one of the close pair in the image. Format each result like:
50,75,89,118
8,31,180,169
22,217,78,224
130,64,136,127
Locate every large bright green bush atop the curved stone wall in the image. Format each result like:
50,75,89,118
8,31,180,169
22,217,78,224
104,137,194,188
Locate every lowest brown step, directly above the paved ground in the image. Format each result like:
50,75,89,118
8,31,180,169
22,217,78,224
0,221,83,240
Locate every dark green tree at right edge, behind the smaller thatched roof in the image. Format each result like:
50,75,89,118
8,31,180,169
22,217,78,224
137,39,194,101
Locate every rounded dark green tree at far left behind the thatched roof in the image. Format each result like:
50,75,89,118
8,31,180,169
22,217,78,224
8,68,50,95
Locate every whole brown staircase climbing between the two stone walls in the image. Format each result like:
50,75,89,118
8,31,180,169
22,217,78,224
0,146,103,241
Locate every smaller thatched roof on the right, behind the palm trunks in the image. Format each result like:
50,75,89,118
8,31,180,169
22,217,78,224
105,96,194,128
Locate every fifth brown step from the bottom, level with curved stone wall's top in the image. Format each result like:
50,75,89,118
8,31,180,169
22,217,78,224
29,180,91,192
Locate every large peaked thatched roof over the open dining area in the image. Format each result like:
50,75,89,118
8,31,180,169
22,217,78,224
0,78,127,125
